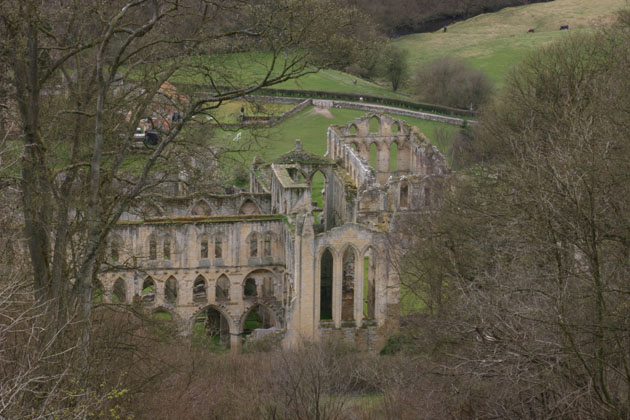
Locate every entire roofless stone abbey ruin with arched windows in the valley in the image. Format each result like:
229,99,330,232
99,114,449,350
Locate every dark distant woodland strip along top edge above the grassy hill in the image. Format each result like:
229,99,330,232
345,0,552,37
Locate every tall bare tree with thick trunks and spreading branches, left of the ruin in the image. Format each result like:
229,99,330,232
0,0,366,348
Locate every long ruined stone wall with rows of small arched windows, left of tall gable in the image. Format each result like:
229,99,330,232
99,216,288,348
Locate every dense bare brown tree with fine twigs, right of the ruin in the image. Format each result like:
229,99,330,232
398,14,630,418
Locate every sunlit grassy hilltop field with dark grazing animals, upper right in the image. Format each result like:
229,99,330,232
394,0,629,86
